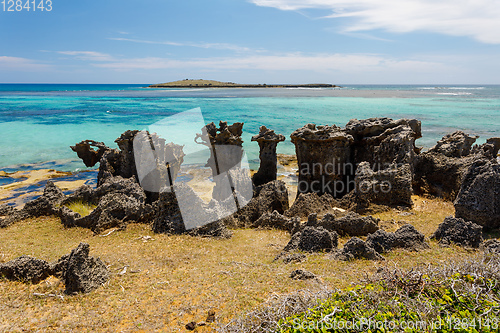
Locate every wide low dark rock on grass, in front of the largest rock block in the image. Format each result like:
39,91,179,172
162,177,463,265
366,224,429,253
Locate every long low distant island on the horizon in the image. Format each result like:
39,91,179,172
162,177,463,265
148,79,341,88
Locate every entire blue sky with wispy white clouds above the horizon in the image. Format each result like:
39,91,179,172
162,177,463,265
0,0,500,84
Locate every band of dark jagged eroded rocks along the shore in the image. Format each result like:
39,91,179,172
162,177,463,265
0,118,500,296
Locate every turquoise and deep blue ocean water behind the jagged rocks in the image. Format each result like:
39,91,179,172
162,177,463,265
0,84,500,171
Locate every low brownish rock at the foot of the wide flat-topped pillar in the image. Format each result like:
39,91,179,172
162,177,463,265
284,192,337,218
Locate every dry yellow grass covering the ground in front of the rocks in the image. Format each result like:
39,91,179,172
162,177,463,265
0,197,482,332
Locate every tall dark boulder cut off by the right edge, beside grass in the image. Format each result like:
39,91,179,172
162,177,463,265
454,159,500,230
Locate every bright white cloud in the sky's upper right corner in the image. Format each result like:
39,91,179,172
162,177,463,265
249,0,500,44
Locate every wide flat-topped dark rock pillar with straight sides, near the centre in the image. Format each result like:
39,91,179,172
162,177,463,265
290,124,354,198
